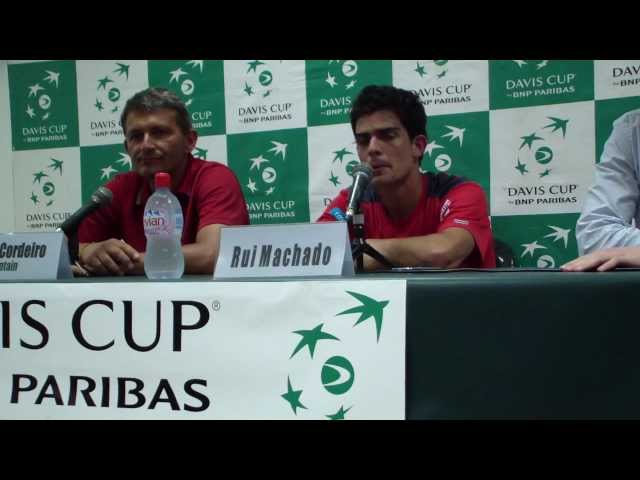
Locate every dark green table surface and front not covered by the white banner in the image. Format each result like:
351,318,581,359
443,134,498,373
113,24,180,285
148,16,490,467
0,269,640,419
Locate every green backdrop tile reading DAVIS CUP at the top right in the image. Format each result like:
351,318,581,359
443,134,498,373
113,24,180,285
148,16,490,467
489,60,594,109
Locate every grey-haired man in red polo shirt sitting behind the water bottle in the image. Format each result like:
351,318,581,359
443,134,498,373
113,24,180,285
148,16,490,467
78,88,249,275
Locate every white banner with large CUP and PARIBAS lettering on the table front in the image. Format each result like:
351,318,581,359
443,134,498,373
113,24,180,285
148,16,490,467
0,279,406,419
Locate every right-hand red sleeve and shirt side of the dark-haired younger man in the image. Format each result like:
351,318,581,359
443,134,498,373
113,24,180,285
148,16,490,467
438,182,496,268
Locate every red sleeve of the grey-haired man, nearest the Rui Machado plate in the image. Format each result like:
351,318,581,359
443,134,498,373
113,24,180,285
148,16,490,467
196,164,249,230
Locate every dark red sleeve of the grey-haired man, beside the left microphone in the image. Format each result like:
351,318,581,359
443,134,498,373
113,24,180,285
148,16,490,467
78,175,126,243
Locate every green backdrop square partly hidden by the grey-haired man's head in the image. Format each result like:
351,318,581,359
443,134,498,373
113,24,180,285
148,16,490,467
148,60,225,136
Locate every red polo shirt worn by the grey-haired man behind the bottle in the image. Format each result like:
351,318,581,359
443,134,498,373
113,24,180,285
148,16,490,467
78,155,249,252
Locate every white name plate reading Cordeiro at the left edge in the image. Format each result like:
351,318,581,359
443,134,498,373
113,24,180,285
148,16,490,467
0,232,73,280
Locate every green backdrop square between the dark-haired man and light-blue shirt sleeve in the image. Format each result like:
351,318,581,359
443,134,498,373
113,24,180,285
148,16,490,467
491,213,579,268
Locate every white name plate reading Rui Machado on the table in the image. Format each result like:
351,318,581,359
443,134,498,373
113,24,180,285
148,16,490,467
213,222,354,279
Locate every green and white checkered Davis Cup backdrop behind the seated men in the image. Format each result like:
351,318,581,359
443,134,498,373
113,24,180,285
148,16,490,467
7,60,640,268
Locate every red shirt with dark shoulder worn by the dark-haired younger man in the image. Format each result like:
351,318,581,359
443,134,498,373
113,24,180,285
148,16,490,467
318,172,496,268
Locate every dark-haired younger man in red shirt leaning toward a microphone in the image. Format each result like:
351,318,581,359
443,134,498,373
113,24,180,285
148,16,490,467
318,85,496,270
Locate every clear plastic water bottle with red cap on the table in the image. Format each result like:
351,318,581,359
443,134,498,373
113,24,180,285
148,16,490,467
143,172,184,279
